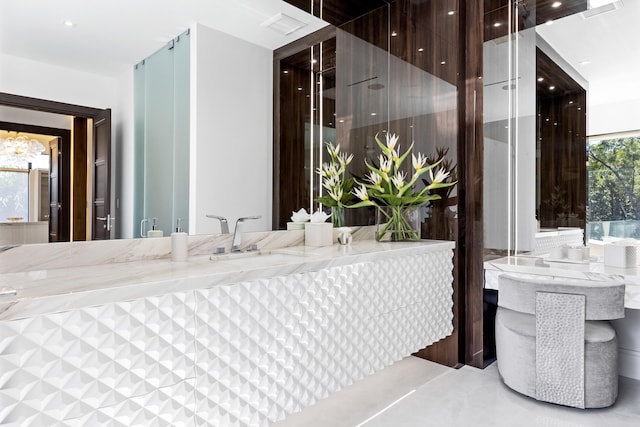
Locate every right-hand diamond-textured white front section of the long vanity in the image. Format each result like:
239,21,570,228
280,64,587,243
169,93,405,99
196,251,453,426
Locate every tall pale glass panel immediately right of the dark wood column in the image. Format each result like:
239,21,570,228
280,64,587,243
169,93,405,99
483,0,537,256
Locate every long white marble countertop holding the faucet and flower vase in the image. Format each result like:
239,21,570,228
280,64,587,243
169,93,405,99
0,240,454,320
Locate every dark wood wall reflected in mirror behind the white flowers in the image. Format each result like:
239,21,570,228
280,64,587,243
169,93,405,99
273,1,459,239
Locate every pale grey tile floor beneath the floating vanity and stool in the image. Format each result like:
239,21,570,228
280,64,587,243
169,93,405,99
273,357,640,427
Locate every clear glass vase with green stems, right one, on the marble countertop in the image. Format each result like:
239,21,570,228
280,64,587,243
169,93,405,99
375,206,420,242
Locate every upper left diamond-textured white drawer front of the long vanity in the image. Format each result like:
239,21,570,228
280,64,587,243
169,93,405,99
0,292,195,426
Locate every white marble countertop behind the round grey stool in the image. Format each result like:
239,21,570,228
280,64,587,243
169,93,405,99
484,255,640,309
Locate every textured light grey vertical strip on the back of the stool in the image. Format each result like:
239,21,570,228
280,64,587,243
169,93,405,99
536,292,586,409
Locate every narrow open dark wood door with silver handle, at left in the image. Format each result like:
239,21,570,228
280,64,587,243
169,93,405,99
91,109,115,240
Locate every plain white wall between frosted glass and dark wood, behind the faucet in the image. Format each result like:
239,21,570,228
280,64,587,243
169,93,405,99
189,25,273,234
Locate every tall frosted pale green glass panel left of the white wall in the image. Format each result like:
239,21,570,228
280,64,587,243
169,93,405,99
134,33,190,236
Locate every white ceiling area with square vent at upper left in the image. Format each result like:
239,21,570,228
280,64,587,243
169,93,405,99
0,0,326,76
